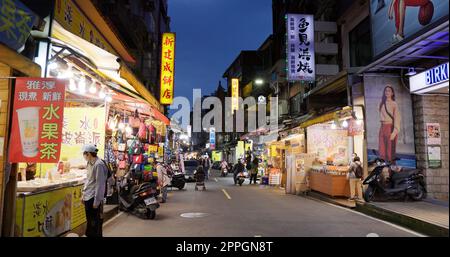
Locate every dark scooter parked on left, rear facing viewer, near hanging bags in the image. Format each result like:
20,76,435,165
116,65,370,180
118,172,159,219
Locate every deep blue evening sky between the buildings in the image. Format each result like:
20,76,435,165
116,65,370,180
169,0,272,106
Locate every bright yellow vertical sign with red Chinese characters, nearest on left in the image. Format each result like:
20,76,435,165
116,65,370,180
160,33,175,104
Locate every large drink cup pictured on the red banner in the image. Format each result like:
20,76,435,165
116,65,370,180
16,107,40,158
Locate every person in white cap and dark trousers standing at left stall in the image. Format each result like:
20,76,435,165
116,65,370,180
82,145,108,237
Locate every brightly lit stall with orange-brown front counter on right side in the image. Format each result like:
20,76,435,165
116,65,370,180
306,109,362,197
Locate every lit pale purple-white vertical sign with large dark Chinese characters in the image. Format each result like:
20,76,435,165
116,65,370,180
286,14,316,81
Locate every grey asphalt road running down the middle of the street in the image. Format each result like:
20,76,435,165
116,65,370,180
103,170,418,237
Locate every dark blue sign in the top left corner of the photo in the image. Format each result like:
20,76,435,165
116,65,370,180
0,0,38,50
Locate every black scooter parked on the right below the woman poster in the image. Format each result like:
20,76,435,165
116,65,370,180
363,159,426,202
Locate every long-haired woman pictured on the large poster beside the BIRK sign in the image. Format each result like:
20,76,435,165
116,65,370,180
378,85,401,162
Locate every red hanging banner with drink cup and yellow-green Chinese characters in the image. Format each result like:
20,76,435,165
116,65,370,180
9,78,65,163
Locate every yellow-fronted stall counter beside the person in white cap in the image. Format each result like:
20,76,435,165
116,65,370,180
15,170,86,237
